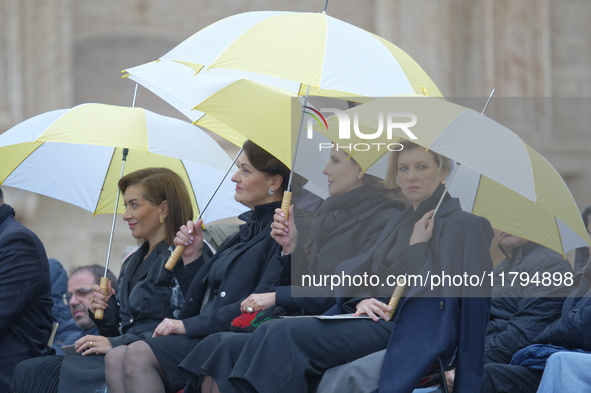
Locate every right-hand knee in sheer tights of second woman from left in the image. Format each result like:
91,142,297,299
123,341,166,393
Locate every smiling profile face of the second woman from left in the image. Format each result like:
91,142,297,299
232,153,281,209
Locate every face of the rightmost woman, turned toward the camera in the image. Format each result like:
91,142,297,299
397,147,447,209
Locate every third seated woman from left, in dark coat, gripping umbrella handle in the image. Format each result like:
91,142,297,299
179,148,405,393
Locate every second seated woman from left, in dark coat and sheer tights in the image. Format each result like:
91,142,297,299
106,141,289,393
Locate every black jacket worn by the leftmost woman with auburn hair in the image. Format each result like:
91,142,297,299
91,241,193,347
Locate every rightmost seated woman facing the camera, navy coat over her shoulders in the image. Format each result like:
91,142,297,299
223,142,492,393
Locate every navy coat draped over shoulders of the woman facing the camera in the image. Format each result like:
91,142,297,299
380,199,493,393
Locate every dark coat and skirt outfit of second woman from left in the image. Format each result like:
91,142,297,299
140,202,283,392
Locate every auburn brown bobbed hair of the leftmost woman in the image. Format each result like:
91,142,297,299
118,168,193,246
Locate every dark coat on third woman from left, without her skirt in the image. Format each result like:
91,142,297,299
276,186,404,314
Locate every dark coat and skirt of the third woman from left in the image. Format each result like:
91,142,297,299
179,186,403,393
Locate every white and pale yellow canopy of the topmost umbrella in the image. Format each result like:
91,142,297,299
150,11,441,96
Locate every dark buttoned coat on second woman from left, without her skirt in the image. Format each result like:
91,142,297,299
174,202,282,337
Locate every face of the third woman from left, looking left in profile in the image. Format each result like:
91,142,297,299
322,147,363,196
